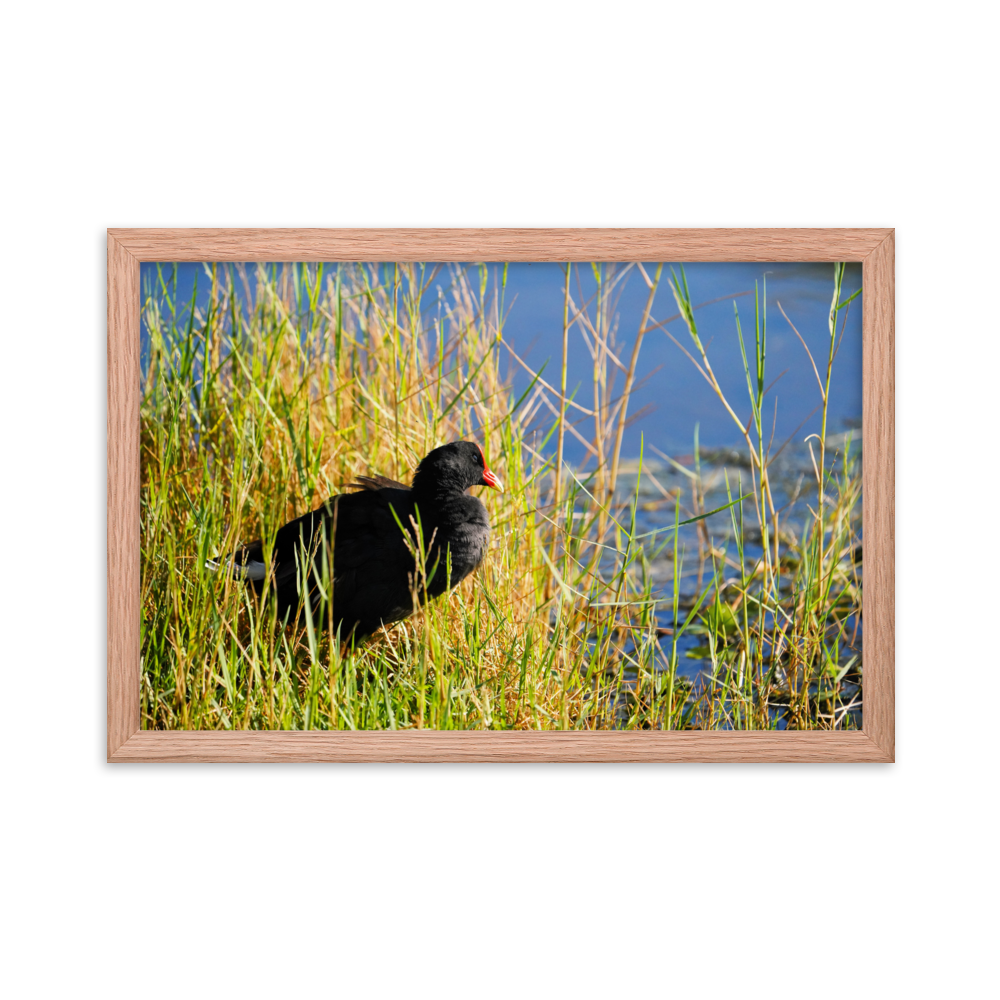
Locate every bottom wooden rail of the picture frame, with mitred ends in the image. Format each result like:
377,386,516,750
112,730,889,764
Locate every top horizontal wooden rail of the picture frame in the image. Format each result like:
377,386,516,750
108,229,891,262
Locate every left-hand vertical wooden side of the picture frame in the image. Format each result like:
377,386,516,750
108,235,140,755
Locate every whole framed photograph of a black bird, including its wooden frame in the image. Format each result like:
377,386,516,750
107,228,895,763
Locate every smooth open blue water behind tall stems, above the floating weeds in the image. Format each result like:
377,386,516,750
496,263,861,459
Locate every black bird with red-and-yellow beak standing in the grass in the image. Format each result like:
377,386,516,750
209,441,503,640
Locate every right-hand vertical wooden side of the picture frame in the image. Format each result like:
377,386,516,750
862,232,896,760
